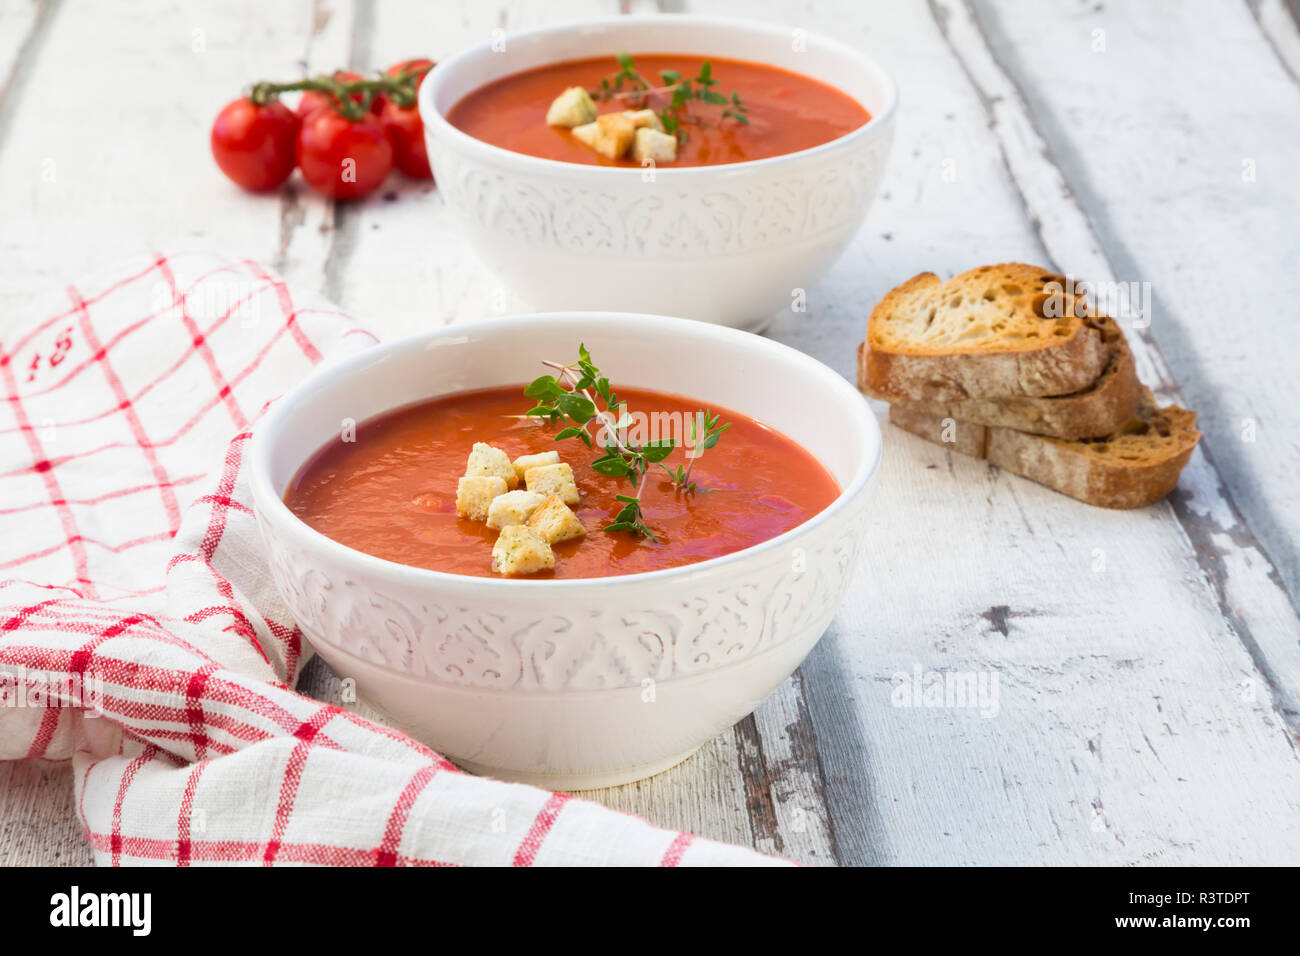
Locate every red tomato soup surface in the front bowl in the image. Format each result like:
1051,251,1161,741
285,384,840,578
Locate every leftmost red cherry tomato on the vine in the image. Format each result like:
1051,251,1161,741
212,96,299,190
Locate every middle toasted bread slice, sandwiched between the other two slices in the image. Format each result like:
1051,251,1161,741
858,316,1141,440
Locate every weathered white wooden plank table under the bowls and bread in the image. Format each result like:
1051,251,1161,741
0,0,1300,864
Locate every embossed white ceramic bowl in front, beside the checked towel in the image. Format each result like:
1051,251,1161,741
250,312,880,790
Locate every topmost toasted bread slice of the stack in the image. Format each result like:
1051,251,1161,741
861,263,1108,402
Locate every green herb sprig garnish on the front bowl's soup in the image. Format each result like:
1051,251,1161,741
524,345,731,541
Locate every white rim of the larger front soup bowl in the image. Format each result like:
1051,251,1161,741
248,312,883,593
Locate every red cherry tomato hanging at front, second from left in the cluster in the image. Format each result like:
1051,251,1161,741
298,109,393,199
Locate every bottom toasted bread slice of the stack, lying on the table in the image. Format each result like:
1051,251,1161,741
889,388,1201,509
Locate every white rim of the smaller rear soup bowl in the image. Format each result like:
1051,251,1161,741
417,13,898,179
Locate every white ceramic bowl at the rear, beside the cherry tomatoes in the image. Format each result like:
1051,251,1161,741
420,16,898,329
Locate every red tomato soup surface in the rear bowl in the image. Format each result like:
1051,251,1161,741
447,53,871,166
